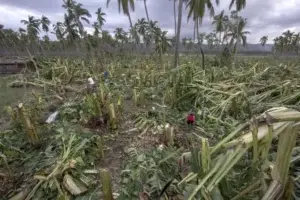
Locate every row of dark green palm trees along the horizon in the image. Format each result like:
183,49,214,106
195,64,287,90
0,0,299,59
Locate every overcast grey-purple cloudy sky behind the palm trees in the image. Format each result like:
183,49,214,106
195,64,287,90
0,0,300,43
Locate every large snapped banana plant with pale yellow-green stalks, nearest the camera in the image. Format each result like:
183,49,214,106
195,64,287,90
178,107,300,200
